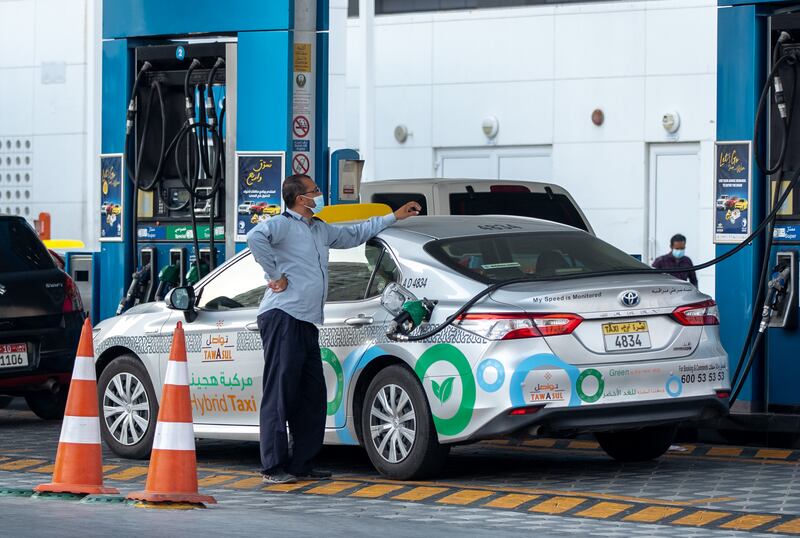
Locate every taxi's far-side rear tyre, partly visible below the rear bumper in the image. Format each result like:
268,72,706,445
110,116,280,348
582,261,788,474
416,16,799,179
594,424,677,462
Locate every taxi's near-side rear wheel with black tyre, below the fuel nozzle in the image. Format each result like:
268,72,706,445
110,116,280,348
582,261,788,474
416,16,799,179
361,365,450,480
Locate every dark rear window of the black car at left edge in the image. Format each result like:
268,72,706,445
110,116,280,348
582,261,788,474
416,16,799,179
0,218,55,273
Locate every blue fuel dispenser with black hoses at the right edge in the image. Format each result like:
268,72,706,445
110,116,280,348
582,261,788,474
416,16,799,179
716,5,800,422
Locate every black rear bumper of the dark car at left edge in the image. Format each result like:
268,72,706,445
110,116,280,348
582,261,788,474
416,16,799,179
0,312,83,394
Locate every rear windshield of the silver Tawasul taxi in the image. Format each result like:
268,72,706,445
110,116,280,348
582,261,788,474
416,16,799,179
425,232,647,283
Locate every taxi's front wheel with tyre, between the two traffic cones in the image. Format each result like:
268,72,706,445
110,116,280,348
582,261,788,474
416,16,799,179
97,354,158,460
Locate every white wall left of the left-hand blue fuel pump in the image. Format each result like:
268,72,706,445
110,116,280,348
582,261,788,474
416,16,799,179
0,0,99,244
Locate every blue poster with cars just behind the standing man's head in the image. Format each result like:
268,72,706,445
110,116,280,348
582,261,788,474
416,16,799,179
236,151,286,242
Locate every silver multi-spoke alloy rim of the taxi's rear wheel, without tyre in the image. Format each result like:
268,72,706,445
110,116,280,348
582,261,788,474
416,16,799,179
370,378,417,463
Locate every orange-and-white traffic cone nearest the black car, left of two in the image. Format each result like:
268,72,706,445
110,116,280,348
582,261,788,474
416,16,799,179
34,319,119,495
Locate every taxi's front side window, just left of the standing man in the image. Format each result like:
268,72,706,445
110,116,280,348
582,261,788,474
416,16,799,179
197,253,267,310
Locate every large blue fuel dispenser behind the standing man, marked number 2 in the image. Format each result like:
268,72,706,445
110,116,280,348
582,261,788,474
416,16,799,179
94,0,329,321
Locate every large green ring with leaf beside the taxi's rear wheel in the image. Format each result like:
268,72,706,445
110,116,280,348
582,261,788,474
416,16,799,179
414,344,476,435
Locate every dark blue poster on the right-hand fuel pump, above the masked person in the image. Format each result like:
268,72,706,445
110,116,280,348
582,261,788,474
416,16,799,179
714,140,752,243
